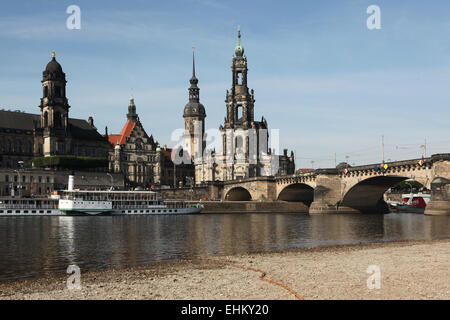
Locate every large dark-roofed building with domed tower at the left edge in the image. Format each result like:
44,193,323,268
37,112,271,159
0,52,110,168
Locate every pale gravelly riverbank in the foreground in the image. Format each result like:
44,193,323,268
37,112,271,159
0,240,450,300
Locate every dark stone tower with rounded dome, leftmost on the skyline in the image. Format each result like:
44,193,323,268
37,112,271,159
39,51,70,156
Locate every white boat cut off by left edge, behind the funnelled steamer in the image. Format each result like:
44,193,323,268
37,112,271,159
0,197,63,216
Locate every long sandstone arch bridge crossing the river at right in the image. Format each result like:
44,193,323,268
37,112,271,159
215,154,450,214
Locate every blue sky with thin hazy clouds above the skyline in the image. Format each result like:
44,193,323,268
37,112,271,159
0,0,450,168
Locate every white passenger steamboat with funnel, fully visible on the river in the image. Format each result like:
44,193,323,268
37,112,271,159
58,190,203,215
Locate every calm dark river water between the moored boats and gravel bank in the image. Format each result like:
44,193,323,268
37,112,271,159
0,214,450,280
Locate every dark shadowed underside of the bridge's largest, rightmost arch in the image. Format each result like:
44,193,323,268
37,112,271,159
340,176,409,213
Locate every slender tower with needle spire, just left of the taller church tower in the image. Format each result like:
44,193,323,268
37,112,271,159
183,48,206,161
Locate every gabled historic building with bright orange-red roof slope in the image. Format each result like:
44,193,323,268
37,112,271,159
107,98,194,188
